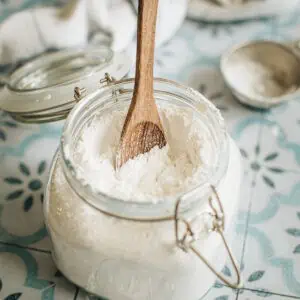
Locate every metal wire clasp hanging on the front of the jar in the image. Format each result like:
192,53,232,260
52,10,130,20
175,186,243,289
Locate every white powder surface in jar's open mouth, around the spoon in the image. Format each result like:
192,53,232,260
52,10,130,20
75,105,216,202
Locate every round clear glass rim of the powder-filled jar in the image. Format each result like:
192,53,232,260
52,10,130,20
60,78,229,220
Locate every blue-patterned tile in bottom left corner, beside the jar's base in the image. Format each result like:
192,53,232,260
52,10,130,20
0,243,76,300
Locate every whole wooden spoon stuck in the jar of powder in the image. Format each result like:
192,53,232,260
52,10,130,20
116,0,166,168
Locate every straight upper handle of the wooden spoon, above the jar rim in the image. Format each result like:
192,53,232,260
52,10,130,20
134,0,158,101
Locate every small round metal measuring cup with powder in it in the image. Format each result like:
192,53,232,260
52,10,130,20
220,41,300,109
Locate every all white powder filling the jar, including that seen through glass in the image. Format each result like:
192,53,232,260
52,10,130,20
44,99,241,300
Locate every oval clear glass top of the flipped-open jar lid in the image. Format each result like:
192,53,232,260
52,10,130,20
8,48,113,92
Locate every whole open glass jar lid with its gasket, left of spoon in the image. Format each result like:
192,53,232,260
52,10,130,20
0,46,131,123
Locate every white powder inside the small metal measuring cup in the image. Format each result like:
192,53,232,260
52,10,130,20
226,58,297,98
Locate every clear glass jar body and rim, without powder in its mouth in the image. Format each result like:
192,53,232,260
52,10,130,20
44,79,241,300
